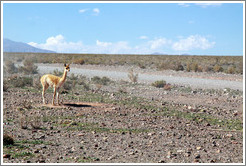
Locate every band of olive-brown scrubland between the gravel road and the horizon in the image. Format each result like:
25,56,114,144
4,53,243,74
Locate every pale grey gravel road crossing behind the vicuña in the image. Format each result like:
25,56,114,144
37,64,243,91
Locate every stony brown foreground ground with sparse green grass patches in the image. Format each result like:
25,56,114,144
3,65,243,163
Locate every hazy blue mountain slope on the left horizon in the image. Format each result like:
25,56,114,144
3,38,55,53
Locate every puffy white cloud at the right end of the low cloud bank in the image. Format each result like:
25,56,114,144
172,35,215,51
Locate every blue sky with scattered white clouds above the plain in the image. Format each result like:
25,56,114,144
3,2,243,55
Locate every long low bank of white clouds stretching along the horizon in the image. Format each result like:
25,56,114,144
28,34,215,54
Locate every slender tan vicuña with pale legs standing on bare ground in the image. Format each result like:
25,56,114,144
40,64,70,105
